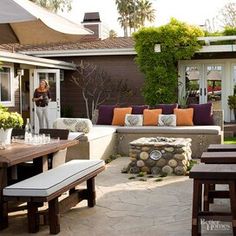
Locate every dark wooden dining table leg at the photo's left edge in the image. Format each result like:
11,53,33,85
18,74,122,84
0,167,8,230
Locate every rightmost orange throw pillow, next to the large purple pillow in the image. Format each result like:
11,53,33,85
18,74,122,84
174,108,193,126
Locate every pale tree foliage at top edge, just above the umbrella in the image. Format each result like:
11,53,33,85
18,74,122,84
30,0,72,13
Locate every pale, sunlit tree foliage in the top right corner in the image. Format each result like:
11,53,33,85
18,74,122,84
217,2,236,27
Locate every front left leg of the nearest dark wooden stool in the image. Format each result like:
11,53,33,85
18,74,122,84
192,179,202,236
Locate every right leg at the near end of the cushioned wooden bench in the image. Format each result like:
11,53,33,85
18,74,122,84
48,198,60,234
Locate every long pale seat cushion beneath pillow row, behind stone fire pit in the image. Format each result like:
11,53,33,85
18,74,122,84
116,125,221,135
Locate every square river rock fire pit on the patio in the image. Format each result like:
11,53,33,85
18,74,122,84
127,137,192,175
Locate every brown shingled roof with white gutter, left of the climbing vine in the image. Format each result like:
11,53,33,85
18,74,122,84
0,37,136,57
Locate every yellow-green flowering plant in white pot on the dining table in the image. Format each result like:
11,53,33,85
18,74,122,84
0,105,23,144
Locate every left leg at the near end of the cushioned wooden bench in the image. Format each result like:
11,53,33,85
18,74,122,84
27,202,39,233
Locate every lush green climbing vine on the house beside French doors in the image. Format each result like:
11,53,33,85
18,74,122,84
134,19,203,105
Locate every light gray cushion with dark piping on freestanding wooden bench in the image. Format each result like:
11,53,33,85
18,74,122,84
3,160,104,197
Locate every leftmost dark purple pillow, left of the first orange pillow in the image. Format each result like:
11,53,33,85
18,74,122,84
97,105,116,125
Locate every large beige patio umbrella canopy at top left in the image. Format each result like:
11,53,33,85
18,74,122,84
0,0,92,44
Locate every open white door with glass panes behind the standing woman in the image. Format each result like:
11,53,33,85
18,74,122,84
31,69,61,133
